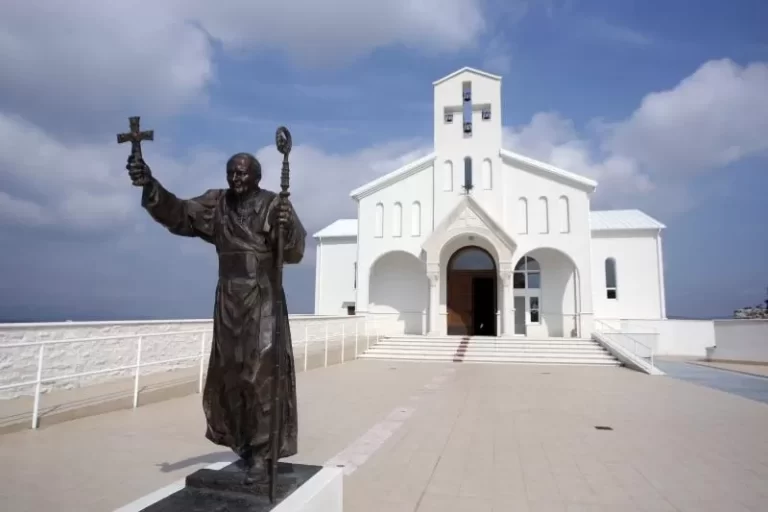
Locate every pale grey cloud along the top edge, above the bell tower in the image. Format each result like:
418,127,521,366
184,0,485,64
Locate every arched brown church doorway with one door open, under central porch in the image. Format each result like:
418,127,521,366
446,246,498,336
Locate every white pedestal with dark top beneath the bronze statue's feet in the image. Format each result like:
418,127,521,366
119,462,343,512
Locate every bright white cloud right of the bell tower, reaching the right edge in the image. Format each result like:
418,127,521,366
505,60,768,209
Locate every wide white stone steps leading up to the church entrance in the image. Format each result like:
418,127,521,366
360,336,621,366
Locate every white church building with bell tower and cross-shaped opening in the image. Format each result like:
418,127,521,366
314,68,666,338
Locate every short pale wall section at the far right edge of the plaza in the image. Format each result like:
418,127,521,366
708,319,768,363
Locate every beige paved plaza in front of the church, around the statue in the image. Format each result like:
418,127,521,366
0,360,768,512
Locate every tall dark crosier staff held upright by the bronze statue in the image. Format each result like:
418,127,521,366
269,126,293,503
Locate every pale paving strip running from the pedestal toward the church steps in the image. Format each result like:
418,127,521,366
324,368,456,476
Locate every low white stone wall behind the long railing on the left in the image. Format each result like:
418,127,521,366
0,315,391,398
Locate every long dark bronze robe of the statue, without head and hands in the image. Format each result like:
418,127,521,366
142,180,306,461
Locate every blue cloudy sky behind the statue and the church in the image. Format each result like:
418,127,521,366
0,0,768,321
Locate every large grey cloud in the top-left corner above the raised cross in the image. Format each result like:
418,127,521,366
0,0,212,117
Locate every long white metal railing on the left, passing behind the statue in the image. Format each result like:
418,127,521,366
0,316,400,429
